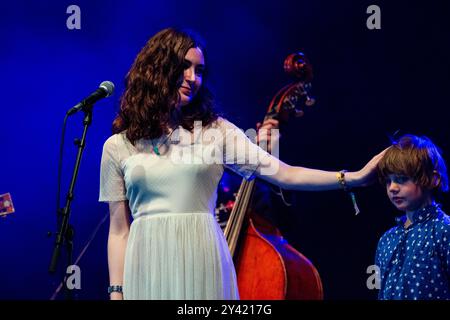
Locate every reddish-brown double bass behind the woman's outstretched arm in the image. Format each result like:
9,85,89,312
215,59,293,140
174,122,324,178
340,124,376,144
224,53,323,300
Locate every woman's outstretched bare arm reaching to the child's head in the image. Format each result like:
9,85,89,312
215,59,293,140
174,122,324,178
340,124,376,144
256,150,385,191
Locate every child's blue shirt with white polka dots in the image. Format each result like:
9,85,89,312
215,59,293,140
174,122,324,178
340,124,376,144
375,204,450,300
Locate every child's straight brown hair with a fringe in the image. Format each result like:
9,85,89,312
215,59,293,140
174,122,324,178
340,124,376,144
377,134,448,195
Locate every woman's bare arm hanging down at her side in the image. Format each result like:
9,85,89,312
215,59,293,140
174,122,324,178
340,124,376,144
108,201,130,300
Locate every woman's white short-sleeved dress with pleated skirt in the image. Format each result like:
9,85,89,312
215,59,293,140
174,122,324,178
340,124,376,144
99,118,269,300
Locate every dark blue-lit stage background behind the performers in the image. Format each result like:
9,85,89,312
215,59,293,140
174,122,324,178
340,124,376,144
0,0,450,299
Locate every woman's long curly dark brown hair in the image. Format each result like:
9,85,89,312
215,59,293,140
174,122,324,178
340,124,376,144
112,28,218,144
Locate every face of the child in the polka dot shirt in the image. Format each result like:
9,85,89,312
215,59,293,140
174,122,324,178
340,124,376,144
386,174,431,212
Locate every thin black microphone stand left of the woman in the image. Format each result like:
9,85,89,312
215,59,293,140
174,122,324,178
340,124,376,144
49,104,93,300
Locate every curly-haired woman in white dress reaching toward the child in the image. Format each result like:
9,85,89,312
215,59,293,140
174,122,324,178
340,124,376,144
99,28,382,300
